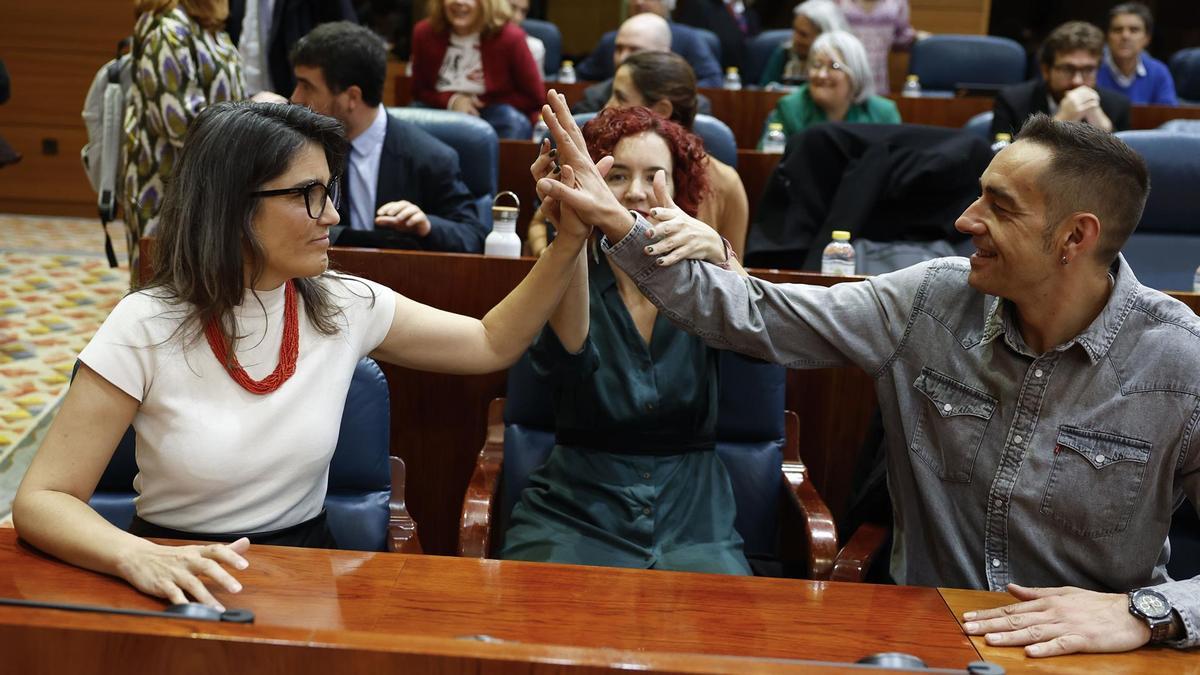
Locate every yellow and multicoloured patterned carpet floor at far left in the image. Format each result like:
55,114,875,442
0,214,128,519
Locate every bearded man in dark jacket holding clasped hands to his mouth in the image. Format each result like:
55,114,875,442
991,22,1129,138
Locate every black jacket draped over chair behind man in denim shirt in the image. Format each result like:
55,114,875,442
745,124,991,270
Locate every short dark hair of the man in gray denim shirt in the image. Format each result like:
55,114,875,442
1016,113,1150,267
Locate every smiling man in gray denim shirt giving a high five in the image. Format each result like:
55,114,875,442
538,96,1200,656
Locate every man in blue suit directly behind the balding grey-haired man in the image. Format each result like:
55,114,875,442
575,0,721,86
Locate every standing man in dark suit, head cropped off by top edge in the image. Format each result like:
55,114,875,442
226,0,358,94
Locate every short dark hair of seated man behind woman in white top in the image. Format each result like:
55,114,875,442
292,22,388,106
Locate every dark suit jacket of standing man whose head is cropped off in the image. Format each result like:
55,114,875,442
226,0,358,96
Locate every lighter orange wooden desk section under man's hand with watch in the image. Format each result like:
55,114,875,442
938,589,1200,675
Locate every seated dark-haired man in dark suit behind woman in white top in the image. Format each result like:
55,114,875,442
292,22,487,252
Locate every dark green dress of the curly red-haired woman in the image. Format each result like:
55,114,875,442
500,256,750,574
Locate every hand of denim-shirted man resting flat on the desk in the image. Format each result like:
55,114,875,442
962,584,1150,657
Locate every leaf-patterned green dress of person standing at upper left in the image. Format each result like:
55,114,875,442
122,7,246,278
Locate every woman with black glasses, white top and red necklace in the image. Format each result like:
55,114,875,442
13,103,588,607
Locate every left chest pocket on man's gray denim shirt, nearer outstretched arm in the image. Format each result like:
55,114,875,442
908,368,997,483
